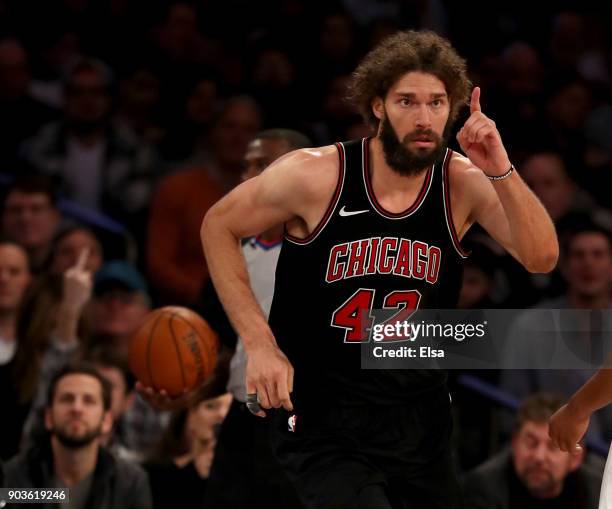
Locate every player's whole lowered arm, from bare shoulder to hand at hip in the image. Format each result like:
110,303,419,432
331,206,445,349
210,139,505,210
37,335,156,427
200,147,338,416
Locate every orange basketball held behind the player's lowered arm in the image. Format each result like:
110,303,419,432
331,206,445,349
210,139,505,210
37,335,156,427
129,306,219,396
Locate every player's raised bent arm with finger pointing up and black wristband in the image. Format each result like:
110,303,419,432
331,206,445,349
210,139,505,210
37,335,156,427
457,87,559,272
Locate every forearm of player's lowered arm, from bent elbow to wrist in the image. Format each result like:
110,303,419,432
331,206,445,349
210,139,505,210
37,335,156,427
201,214,276,351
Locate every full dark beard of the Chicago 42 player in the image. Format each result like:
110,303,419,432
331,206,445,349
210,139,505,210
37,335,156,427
378,113,450,176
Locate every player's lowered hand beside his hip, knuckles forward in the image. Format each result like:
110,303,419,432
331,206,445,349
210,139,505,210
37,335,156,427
246,344,293,417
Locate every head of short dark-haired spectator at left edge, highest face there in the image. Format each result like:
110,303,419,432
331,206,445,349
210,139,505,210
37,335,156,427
2,177,61,273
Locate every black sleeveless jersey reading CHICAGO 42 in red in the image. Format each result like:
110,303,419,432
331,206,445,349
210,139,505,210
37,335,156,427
270,138,466,412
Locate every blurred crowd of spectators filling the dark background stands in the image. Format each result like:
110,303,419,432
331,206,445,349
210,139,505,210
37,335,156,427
0,0,612,508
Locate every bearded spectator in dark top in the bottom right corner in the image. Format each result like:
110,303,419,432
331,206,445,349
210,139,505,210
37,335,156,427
465,393,602,509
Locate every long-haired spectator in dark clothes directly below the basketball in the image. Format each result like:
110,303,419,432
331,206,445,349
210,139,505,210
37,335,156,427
146,394,232,509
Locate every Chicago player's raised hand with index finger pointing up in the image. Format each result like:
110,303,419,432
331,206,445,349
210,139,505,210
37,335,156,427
457,87,511,176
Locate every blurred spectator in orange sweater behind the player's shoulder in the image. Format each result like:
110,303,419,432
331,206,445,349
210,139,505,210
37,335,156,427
147,97,261,305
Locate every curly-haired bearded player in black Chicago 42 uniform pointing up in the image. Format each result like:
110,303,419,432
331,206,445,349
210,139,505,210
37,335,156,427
201,32,558,509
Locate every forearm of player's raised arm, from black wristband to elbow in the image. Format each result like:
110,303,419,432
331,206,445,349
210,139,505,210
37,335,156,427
493,172,559,272
